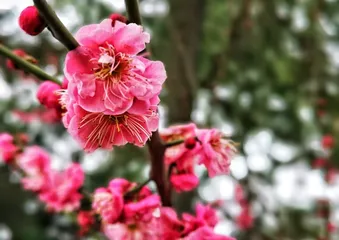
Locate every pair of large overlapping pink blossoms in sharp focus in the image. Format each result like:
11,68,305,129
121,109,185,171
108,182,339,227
61,19,166,152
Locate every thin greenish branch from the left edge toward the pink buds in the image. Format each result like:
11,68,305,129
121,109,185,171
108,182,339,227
0,44,61,84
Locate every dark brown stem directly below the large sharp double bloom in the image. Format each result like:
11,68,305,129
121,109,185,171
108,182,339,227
148,131,172,206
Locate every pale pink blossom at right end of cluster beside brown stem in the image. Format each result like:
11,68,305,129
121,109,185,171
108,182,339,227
197,129,236,177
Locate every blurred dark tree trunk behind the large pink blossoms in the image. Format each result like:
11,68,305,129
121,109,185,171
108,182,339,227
157,0,205,212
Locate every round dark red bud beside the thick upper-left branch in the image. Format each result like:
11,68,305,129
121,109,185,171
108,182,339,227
19,6,47,36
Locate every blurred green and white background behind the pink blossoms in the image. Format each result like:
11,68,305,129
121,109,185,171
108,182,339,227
0,0,339,240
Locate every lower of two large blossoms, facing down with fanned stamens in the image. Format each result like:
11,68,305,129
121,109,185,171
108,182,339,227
63,97,159,152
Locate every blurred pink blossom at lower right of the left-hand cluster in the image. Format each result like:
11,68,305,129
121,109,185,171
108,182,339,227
39,163,85,212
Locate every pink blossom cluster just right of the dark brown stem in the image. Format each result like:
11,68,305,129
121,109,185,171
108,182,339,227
160,123,236,192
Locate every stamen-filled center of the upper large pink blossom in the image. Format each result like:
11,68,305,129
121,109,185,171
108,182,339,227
91,44,131,83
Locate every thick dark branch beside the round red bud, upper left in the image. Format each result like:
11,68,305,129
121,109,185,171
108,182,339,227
33,0,79,51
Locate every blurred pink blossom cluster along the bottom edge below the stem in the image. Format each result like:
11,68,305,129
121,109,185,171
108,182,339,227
78,178,233,240
